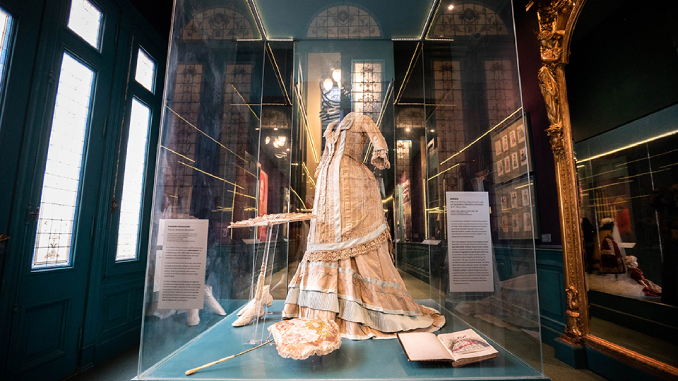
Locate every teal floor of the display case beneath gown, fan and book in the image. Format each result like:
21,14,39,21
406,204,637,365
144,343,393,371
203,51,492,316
135,300,548,380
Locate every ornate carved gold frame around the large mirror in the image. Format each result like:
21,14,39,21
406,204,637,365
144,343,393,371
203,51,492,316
527,0,678,379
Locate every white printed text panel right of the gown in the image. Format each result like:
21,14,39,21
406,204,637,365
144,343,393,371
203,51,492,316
445,192,494,292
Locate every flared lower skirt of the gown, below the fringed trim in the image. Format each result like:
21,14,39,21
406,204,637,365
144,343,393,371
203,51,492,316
283,242,445,340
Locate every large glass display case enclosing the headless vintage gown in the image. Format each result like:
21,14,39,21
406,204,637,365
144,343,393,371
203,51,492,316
137,0,546,380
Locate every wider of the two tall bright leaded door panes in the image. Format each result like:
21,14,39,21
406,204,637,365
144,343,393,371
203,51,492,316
33,53,94,268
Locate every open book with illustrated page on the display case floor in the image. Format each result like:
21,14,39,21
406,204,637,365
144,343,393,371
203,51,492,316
398,329,499,367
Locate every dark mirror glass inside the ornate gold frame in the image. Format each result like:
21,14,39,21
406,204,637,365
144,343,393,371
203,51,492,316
565,1,678,367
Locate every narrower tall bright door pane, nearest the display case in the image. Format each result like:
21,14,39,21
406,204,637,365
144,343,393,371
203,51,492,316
115,98,151,261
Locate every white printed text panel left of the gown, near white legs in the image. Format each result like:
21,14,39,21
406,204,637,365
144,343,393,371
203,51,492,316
156,219,209,309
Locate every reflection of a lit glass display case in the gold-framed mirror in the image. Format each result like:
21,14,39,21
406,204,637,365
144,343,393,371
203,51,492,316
574,105,678,366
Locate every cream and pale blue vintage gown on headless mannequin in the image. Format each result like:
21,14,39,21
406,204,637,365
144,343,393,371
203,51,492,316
283,113,445,340
